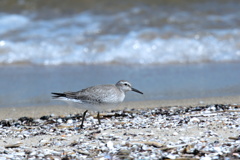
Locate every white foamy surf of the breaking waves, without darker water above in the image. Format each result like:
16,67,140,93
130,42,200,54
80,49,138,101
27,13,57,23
0,8,240,65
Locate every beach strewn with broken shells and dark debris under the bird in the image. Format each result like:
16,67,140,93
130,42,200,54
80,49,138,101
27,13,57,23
0,97,240,159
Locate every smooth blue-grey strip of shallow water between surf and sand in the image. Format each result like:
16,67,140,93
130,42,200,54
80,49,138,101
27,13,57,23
0,63,240,107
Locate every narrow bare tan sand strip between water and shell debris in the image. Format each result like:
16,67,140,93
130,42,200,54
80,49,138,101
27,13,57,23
0,96,240,120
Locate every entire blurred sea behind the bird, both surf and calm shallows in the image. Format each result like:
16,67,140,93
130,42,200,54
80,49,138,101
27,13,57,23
0,0,240,107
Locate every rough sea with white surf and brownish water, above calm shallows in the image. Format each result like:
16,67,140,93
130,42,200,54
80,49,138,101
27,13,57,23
0,0,240,65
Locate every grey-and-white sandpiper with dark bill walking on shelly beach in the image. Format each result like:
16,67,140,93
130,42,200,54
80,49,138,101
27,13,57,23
52,80,143,128
